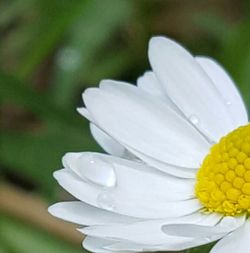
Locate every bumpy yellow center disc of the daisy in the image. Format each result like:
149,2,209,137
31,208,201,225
195,124,250,216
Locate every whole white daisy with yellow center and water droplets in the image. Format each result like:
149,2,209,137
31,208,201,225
49,37,250,253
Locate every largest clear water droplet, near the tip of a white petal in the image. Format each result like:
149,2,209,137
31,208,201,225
77,154,116,187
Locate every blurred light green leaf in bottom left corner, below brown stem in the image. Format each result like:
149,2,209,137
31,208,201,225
0,214,84,253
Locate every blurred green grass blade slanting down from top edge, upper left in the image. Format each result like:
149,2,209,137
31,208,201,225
15,0,91,78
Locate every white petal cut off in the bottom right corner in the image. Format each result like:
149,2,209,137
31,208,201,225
210,220,250,253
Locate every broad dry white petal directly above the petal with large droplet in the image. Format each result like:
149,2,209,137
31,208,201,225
83,81,210,168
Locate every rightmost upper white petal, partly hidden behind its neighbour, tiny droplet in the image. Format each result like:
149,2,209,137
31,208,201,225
196,57,248,125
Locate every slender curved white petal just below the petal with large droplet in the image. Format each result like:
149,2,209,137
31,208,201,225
54,170,201,219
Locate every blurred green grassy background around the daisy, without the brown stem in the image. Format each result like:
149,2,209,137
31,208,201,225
0,0,250,253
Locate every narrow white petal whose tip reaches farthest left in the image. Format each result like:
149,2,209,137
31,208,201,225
48,201,139,226
